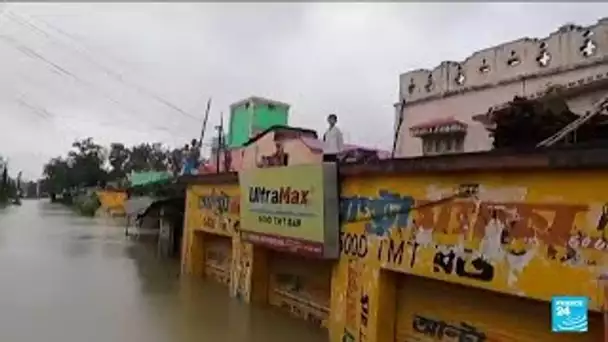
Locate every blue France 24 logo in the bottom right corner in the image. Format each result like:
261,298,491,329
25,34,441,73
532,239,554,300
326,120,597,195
551,296,589,332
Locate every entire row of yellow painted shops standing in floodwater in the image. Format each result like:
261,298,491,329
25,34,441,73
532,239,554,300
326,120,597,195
100,151,608,342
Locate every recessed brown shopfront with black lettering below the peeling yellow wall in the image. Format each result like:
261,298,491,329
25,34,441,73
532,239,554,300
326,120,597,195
395,275,603,342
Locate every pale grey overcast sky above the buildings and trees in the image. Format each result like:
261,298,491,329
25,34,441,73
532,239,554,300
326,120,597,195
0,3,608,178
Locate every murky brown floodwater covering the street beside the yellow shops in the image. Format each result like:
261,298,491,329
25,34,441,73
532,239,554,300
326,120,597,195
0,200,327,342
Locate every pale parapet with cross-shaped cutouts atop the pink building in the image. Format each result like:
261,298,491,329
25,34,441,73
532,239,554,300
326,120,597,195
399,18,608,103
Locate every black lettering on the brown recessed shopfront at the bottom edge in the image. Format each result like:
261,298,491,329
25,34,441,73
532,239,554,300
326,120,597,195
412,315,487,342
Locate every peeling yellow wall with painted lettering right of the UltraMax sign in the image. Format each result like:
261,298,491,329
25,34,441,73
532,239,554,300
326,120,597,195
330,170,608,342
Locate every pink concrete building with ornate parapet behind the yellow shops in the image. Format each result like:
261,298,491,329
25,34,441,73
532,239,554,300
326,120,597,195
395,19,608,157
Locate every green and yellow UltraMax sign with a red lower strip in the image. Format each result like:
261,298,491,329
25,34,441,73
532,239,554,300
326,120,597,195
239,163,339,258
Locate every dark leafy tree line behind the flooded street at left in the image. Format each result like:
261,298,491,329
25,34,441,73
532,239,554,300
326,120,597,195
41,137,197,195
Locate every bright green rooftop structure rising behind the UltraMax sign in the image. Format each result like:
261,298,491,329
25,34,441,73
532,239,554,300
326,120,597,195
226,96,289,147
